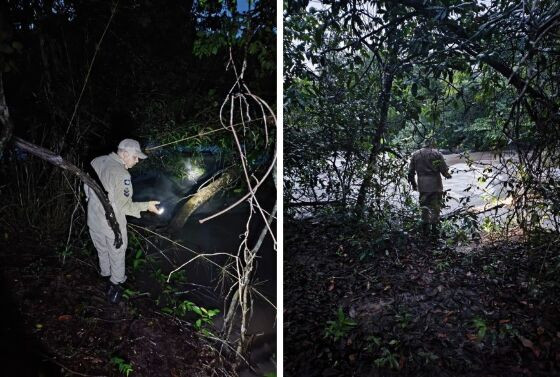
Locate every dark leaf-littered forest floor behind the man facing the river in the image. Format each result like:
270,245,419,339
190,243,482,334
284,216,560,377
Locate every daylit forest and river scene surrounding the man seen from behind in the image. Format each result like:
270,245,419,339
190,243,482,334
283,0,560,377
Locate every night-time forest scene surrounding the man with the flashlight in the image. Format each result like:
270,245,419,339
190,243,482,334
0,0,276,376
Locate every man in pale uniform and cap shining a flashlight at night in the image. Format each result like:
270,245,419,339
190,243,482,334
84,139,159,303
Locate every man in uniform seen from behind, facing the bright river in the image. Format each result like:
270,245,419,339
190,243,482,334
408,139,451,236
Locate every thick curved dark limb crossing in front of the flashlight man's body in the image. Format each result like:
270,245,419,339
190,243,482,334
13,137,122,248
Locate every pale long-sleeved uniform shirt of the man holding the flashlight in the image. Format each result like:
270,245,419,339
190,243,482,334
84,152,148,238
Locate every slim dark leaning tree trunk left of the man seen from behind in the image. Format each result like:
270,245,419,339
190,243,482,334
356,63,396,215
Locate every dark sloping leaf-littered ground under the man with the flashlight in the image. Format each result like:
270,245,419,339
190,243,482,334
0,241,235,377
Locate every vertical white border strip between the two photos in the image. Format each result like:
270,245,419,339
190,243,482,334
276,0,284,377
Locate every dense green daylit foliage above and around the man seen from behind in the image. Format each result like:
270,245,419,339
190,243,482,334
284,0,560,229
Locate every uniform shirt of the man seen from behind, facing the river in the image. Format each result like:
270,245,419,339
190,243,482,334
408,148,450,192
